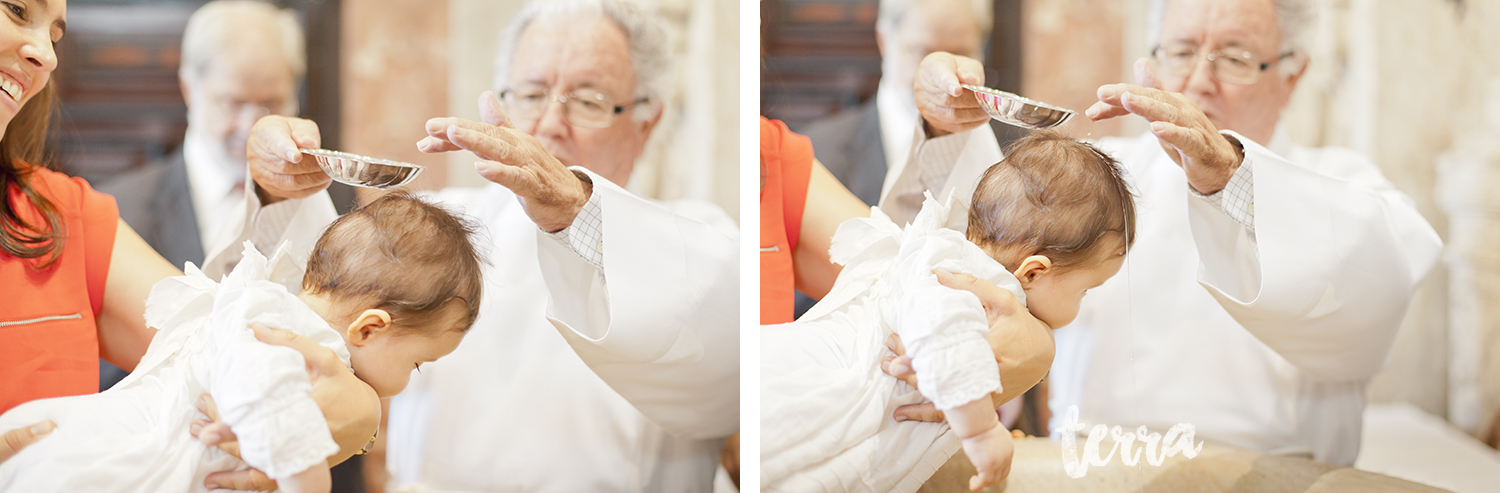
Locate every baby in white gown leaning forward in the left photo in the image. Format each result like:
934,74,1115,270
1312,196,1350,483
0,195,483,492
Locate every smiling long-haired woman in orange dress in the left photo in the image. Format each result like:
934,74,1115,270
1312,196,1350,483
0,0,374,480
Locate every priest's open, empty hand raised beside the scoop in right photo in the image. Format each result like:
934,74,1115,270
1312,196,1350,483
1085,58,1245,195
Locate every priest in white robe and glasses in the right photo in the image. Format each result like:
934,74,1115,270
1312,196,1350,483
888,0,1442,465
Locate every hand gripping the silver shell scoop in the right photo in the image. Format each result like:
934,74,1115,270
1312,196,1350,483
912,51,990,138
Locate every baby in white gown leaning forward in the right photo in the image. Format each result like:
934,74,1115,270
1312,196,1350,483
761,132,1136,492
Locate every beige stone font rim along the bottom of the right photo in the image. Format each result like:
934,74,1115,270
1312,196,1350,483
918,438,1446,493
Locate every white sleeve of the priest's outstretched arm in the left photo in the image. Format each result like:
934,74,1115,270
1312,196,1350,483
537,168,740,439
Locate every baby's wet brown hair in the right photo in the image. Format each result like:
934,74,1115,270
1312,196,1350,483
968,130,1136,268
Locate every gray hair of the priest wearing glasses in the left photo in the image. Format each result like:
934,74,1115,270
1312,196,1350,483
495,0,672,121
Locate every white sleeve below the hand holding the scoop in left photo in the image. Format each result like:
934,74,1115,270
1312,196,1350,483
199,184,339,280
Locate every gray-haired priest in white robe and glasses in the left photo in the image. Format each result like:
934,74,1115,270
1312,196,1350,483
199,0,740,492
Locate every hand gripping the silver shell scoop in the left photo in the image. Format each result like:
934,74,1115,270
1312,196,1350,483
245,115,333,205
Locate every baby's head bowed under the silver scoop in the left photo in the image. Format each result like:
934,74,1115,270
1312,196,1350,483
292,193,483,397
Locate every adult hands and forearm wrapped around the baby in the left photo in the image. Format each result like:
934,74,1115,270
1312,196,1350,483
189,324,380,492
